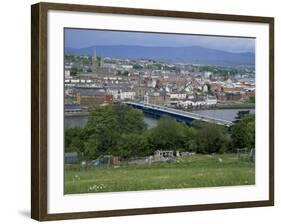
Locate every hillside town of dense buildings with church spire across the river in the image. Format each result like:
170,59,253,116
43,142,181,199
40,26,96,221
64,50,255,112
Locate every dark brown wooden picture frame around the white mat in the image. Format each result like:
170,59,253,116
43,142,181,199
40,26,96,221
31,3,274,221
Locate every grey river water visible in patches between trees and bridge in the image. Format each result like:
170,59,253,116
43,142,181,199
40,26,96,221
64,109,255,128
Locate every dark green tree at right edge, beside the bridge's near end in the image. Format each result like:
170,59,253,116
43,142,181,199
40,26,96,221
231,114,255,149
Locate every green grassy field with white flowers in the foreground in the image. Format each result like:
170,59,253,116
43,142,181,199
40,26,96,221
65,154,255,194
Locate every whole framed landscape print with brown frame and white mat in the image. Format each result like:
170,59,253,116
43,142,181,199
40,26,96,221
31,3,274,221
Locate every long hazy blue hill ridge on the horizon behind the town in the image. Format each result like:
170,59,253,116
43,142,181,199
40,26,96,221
65,45,255,65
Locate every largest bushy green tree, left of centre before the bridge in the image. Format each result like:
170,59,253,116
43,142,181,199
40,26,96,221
82,104,146,158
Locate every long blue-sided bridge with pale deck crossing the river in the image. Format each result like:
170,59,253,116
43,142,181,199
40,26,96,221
125,102,233,127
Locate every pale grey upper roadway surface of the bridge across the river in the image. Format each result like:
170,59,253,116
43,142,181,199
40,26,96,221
126,102,233,126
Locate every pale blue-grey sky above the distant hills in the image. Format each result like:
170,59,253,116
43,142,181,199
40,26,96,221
65,28,255,53
